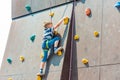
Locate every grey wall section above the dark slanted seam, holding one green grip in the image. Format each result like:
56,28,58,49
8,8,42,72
12,0,72,18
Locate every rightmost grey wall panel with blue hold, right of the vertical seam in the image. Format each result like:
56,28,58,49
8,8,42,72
101,0,120,64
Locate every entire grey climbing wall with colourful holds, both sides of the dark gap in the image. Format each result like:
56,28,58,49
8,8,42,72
0,0,120,80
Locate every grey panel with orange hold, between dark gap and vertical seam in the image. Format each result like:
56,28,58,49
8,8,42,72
75,0,102,67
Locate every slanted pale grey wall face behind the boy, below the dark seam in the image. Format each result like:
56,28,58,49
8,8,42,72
0,4,72,80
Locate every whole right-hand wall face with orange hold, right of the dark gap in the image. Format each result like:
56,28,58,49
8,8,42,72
72,0,120,80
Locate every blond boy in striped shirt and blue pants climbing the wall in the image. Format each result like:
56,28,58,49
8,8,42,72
40,18,64,75
